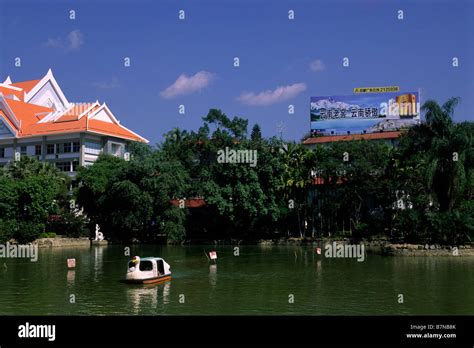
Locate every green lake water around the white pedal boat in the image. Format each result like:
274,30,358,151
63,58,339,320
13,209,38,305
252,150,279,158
0,246,474,315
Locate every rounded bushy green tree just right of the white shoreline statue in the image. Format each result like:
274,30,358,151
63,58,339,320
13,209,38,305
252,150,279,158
77,147,189,241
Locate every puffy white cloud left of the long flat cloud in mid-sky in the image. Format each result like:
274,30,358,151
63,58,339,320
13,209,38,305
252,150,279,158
160,70,215,99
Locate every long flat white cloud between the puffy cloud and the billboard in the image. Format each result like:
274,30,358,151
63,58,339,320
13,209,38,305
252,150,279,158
238,83,306,106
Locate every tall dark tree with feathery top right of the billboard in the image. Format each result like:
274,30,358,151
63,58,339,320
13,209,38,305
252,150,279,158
396,98,473,243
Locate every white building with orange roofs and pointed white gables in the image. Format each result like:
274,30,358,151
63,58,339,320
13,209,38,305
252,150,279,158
0,69,148,176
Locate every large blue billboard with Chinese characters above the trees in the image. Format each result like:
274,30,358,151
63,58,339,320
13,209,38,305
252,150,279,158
311,92,420,135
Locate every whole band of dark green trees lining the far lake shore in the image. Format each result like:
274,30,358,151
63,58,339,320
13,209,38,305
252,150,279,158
0,99,474,244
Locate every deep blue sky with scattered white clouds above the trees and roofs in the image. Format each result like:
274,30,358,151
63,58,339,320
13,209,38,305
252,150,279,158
0,0,474,143
